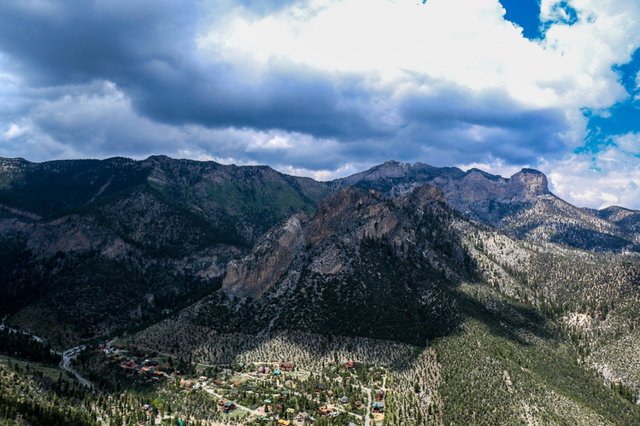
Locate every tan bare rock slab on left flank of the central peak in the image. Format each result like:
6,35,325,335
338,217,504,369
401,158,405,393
222,216,304,299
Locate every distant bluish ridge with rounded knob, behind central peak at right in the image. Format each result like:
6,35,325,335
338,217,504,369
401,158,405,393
333,161,640,251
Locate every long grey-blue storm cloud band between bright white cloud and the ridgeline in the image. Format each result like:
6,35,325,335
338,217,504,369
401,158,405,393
0,0,568,169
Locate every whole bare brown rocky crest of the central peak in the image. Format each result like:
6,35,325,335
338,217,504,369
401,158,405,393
222,185,458,300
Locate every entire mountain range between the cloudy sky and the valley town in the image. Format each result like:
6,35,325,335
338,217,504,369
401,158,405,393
0,157,640,425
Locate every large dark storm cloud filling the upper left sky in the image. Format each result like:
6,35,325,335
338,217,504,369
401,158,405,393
0,0,384,138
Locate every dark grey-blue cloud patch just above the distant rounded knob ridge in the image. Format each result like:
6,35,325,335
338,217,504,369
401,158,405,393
399,88,570,163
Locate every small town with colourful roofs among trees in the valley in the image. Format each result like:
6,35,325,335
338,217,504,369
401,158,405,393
76,341,387,426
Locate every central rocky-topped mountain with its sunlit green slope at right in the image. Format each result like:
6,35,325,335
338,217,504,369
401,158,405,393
135,178,640,425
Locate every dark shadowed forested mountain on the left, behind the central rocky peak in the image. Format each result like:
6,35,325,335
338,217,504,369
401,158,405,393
0,157,327,340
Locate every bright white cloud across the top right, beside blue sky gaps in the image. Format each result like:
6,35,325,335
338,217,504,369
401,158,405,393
199,0,640,116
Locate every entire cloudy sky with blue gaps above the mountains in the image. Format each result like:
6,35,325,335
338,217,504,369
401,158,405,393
0,0,640,208
